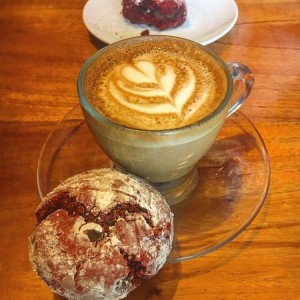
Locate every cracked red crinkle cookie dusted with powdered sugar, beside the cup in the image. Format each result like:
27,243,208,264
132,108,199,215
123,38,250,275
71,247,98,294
29,169,173,300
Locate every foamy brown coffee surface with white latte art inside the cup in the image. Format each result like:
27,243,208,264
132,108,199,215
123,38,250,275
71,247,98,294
84,40,228,130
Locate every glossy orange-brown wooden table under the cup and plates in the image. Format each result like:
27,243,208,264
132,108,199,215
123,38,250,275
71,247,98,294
0,0,300,300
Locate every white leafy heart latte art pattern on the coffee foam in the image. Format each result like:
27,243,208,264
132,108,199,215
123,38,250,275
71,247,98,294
109,59,196,117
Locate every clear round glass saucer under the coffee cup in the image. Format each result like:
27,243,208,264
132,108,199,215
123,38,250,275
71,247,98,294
37,105,270,262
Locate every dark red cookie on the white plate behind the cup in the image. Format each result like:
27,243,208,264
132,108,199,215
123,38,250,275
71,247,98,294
122,0,187,30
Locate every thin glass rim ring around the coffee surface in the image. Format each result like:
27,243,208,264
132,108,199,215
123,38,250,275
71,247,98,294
77,35,233,135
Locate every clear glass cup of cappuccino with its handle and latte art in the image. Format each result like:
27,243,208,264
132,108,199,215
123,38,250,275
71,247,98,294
77,35,253,199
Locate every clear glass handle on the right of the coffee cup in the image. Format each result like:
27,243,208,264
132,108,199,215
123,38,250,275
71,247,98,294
226,62,254,118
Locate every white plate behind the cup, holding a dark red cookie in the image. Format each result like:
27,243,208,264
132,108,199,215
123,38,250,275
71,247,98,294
83,0,238,45
